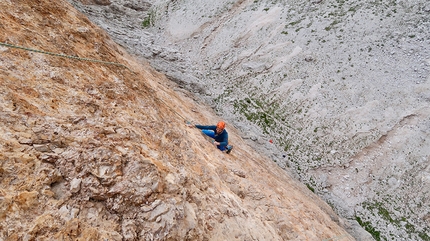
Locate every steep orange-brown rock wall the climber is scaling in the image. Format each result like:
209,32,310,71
0,0,353,240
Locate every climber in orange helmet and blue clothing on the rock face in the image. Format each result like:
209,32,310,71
191,121,233,154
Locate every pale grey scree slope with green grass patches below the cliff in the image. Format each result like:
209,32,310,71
66,0,430,241
